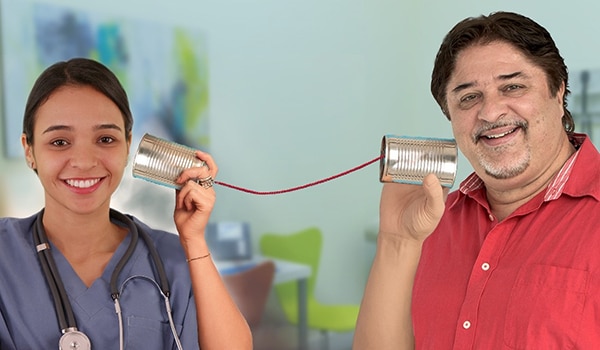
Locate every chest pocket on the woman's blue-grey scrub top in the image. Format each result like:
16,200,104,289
125,316,182,350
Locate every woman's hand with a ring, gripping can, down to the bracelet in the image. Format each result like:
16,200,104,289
174,151,218,250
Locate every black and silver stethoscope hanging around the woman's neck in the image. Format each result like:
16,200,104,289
33,209,182,350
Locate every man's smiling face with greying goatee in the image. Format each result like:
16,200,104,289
446,41,565,186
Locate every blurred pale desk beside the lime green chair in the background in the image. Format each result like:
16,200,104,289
215,257,312,350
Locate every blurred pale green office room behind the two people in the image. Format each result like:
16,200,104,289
0,0,600,350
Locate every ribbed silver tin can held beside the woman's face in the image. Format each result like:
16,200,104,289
133,134,204,189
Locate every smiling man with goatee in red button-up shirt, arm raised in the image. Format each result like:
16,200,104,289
354,12,600,350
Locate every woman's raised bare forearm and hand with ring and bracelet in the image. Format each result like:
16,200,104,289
174,151,252,349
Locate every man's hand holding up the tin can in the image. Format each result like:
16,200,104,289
379,174,448,241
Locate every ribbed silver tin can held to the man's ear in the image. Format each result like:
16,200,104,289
379,135,458,187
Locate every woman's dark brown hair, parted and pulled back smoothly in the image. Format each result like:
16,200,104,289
23,58,133,145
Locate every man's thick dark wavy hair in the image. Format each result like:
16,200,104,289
431,12,575,133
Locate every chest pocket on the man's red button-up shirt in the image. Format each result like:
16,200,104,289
504,265,588,350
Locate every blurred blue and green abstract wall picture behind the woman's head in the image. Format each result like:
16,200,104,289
0,0,210,158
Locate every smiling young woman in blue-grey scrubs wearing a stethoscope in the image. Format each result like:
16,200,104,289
0,58,252,350
